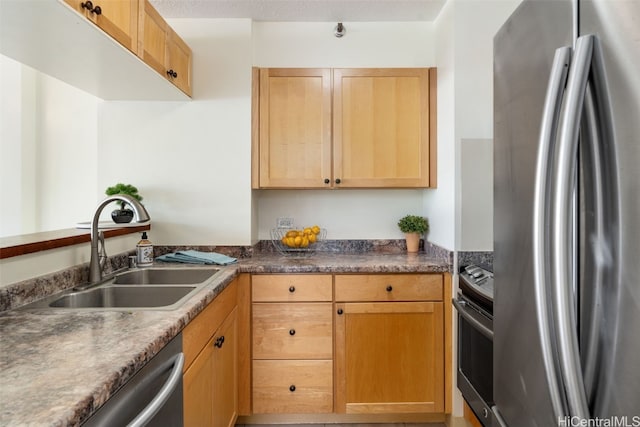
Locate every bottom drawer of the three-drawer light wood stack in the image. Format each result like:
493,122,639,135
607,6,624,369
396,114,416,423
253,360,333,414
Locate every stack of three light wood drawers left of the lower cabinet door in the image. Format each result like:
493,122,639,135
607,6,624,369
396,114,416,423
252,275,333,414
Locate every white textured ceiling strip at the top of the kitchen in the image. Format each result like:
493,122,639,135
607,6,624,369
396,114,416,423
151,0,446,22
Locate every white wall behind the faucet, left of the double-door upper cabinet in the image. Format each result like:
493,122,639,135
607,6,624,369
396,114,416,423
98,19,252,245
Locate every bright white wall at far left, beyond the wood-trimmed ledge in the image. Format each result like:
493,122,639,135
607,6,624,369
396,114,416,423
0,56,100,236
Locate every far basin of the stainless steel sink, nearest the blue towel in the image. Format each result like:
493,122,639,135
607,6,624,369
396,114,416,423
113,268,219,285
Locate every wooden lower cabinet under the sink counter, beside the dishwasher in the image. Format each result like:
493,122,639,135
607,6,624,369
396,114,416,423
183,282,238,427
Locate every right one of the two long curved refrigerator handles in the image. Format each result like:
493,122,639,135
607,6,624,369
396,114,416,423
551,36,594,419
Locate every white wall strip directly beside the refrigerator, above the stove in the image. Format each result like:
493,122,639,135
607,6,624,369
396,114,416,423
454,0,521,251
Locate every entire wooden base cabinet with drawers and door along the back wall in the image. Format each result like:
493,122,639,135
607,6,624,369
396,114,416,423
240,273,452,424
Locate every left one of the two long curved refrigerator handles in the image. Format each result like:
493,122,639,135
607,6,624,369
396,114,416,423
532,46,572,419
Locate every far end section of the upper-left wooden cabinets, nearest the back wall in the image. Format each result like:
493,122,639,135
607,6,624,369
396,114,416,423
138,0,192,96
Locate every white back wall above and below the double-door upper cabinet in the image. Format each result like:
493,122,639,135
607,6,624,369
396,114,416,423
253,22,439,239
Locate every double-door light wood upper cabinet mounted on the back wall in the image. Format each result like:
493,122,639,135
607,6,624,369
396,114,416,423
253,68,436,188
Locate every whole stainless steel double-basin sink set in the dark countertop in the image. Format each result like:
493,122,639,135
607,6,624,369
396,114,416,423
24,268,222,310
